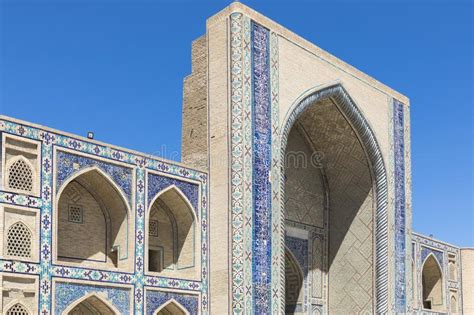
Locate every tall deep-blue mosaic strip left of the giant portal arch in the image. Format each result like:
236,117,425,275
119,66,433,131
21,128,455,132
251,23,272,314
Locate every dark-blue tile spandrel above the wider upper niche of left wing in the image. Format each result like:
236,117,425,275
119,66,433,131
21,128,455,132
56,151,133,205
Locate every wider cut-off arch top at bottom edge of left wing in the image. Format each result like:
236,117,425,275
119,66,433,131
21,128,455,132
62,293,120,315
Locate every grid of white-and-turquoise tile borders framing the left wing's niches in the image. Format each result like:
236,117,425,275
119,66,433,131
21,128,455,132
0,118,209,315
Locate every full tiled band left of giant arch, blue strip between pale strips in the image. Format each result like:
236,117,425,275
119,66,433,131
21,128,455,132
230,13,284,313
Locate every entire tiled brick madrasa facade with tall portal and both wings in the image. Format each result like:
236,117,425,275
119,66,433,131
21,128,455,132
0,3,474,315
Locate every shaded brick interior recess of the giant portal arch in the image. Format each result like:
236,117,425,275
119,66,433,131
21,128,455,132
283,86,386,314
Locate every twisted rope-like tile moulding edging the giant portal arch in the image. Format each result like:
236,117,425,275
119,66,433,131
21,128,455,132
273,84,389,314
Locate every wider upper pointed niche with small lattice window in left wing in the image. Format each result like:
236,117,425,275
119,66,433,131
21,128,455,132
55,167,132,269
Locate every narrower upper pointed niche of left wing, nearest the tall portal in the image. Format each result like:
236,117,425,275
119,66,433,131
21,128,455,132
146,185,200,276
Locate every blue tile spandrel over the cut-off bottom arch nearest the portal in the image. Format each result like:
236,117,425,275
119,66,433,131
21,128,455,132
146,290,199,315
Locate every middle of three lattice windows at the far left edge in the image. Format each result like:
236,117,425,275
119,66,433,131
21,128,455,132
7,222,32,258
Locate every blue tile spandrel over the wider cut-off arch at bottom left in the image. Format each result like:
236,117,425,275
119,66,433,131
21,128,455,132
54,282,131,315
